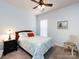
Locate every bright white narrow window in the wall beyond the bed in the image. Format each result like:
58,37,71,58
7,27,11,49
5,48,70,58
40,19,48,36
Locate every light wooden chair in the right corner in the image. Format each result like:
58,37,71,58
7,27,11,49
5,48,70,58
64,35,78,56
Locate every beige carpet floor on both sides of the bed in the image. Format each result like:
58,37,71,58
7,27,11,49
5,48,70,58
1,46,79,59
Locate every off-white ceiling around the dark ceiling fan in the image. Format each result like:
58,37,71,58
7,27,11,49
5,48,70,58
1,0,79,15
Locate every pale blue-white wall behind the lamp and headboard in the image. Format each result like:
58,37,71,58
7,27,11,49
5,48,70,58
0,0,36,41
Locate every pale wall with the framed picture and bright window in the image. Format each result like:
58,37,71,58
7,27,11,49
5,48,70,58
36,3,79,46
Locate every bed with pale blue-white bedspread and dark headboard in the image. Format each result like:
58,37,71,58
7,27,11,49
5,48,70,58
16,30,52,59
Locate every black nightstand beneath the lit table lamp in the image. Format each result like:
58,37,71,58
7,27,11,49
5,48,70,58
3,40,17,55
